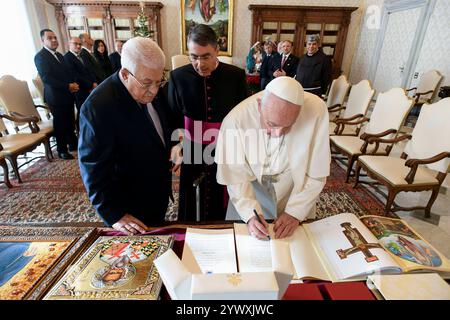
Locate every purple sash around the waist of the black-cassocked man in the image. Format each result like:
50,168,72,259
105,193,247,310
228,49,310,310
184,116,222,144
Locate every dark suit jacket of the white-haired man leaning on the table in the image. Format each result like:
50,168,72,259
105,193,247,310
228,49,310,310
78,73,172,225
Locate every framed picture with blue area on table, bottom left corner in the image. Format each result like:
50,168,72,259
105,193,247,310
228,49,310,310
0,227,93,300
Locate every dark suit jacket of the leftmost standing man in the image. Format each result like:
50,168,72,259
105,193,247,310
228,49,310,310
34,48,74,108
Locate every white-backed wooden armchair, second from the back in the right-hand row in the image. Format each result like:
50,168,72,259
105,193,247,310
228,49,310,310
330,80,375,136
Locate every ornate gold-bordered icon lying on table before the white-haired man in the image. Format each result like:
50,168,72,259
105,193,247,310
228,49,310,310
44,235,173,300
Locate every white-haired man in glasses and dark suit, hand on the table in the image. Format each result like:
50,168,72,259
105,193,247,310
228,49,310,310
78,37,172,235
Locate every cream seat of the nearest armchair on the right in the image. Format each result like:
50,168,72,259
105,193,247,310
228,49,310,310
358,156,439,186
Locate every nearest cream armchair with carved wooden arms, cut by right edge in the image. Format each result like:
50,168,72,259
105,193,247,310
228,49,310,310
354,98,450,218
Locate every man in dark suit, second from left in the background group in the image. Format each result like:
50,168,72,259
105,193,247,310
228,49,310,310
64,37,97,131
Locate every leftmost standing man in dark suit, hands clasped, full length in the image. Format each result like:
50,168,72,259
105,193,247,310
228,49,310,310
34,29,79,160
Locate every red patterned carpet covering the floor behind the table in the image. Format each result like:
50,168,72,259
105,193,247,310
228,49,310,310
0,159,383,223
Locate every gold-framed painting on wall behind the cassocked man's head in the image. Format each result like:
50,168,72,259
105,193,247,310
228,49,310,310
181,0,233,56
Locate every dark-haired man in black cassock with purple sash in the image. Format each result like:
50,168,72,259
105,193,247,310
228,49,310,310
169,24,248,221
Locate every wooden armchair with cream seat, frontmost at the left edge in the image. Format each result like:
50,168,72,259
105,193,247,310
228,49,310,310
0,114,51,188
